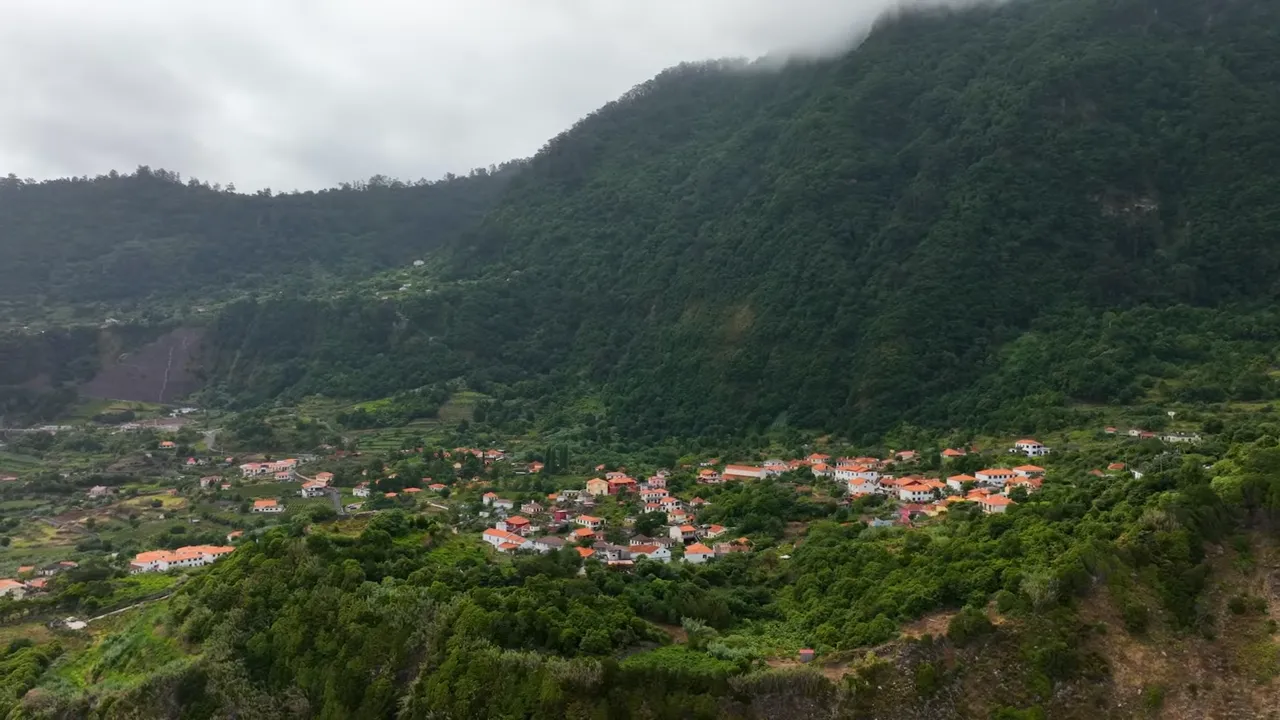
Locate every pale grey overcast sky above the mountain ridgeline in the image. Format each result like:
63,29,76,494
0,0,962,191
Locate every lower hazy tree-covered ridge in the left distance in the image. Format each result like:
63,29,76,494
0,163,520,305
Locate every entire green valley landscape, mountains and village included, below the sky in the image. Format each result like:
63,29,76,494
0,0,1280,720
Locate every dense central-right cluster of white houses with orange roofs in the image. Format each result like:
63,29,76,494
460,430,1141,568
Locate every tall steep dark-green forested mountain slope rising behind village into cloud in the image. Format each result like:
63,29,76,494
204,0,1280,437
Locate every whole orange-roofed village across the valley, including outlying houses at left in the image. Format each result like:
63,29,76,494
0,409,1199,598
